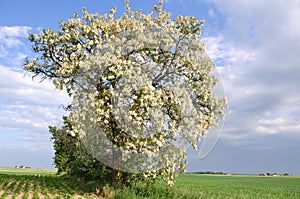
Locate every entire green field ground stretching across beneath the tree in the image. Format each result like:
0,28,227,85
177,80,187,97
0,168,300,199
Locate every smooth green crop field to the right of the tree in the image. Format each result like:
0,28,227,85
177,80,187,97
172,174,300,199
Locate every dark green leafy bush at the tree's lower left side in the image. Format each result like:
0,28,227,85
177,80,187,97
49,116,111,180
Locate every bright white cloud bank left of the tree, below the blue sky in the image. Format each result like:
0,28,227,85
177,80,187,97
0,65,70,150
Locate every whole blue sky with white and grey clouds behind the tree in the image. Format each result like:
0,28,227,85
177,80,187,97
0,0,300,175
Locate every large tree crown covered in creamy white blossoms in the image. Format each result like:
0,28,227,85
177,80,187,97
24,1,226,184
